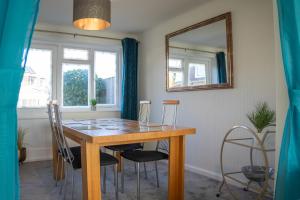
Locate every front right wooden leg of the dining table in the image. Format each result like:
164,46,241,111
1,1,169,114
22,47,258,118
168,136,185,200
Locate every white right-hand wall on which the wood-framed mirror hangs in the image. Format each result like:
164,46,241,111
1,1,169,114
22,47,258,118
139,0,275,178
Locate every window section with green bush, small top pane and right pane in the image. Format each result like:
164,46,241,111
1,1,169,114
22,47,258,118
61,48,119,108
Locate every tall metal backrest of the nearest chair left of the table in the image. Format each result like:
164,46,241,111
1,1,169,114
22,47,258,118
52,102,74,163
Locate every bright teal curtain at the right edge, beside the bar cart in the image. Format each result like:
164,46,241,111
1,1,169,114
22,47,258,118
275,0,300,200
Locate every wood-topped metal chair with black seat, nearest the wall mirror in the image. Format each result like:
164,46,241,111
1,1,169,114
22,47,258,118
121,100,179,200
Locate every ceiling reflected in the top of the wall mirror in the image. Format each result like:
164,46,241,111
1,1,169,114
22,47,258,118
171,20,227,49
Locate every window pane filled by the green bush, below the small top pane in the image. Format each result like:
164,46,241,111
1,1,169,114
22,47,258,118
62,63,89,106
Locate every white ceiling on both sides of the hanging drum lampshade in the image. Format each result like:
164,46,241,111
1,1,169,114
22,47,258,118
39,0,209,33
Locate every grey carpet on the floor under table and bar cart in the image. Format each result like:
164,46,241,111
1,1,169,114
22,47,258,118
20,161,264,200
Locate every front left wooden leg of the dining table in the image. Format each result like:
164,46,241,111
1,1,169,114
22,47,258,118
81,141,101,200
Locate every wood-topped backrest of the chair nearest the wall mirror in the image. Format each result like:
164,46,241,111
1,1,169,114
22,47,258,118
156,100,180,153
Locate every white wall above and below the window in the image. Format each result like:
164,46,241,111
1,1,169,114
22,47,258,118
18,24,137,161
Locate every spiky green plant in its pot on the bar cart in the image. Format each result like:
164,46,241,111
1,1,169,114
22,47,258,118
247,102,275,143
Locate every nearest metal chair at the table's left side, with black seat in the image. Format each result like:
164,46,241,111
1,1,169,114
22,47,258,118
48,103,118,200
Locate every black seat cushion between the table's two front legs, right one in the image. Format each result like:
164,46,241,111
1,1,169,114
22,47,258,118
121,150,169,162
